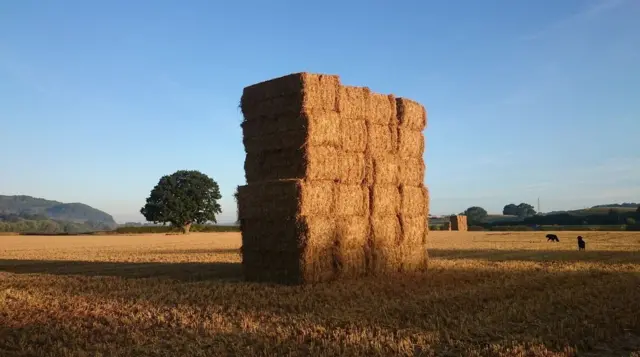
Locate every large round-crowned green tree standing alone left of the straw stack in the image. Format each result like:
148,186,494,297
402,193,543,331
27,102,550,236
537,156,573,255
140,170,222,234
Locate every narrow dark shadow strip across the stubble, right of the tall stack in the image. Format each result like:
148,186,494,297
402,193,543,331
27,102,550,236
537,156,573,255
429,248,640,264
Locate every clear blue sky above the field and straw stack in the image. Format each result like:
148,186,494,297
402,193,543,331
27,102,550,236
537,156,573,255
0,0,640,221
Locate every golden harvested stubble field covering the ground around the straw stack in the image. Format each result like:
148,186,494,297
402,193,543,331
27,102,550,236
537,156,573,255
0,232,640,356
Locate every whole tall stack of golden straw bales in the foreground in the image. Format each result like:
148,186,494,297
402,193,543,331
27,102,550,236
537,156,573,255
238,73,429,284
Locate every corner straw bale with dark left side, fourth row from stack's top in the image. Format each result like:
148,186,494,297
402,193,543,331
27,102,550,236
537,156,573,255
238,180,335,219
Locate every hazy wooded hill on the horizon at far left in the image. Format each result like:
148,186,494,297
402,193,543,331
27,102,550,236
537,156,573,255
0,195,117,229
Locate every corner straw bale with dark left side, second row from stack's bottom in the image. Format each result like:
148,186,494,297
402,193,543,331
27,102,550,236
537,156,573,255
240,216,336,252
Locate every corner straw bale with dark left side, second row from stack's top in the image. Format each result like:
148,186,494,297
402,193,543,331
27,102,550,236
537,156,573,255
241,112,340,153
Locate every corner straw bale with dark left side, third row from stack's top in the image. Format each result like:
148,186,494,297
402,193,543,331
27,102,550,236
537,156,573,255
244,146,344,184
